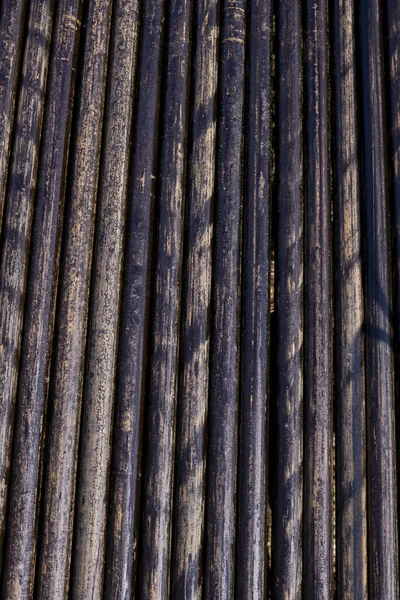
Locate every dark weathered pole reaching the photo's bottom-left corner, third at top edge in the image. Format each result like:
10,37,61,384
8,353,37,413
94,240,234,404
2,0,81,599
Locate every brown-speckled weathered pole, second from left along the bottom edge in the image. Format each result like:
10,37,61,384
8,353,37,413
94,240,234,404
37,0,111,599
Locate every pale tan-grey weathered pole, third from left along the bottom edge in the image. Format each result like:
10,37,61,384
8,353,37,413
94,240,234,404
71,0,138,599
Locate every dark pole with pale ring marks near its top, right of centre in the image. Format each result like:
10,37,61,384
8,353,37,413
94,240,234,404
204,0,246,600
